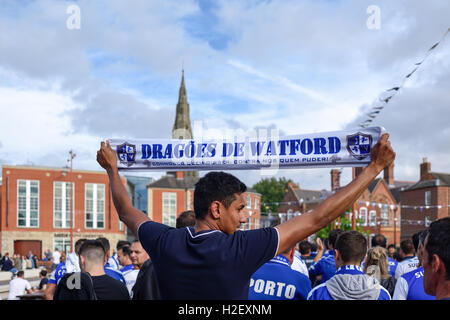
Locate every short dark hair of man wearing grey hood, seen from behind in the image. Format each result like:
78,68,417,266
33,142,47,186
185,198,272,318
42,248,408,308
335,231,367,263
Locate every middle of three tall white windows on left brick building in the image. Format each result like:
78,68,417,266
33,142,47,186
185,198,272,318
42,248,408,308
53,181,75,228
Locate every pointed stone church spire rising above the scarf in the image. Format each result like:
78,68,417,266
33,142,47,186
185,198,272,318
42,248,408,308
172,68,193,139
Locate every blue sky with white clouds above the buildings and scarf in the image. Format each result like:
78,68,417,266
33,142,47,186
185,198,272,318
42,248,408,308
0,0,450,189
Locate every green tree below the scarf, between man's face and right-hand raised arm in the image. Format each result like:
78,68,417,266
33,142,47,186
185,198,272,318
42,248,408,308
252,177,292,212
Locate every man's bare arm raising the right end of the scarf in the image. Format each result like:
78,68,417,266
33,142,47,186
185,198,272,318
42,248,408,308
275,133,395,254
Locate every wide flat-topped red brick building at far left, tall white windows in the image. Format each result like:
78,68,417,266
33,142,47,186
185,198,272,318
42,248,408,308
0,165,126,257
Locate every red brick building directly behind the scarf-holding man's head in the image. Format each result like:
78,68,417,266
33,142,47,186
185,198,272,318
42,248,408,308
148,171,261,230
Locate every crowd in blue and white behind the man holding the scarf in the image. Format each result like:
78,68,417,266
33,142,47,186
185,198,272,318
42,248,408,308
0,211,450,300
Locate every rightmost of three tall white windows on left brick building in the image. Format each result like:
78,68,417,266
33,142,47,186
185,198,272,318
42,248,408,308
85,183,105,229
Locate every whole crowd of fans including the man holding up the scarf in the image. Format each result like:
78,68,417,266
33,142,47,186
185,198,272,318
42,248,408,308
0,134,450,300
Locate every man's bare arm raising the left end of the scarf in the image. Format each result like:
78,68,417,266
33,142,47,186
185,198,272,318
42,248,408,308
97,140,150,237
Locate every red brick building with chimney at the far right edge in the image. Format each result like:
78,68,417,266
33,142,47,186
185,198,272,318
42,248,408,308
400,158,450,240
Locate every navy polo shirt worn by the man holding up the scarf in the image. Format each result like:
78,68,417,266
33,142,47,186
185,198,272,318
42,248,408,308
138,221,279,300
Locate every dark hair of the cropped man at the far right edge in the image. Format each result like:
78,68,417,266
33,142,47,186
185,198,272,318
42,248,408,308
425,218,450,280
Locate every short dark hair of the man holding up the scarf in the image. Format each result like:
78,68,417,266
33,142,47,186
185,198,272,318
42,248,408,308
194,172,247,220
